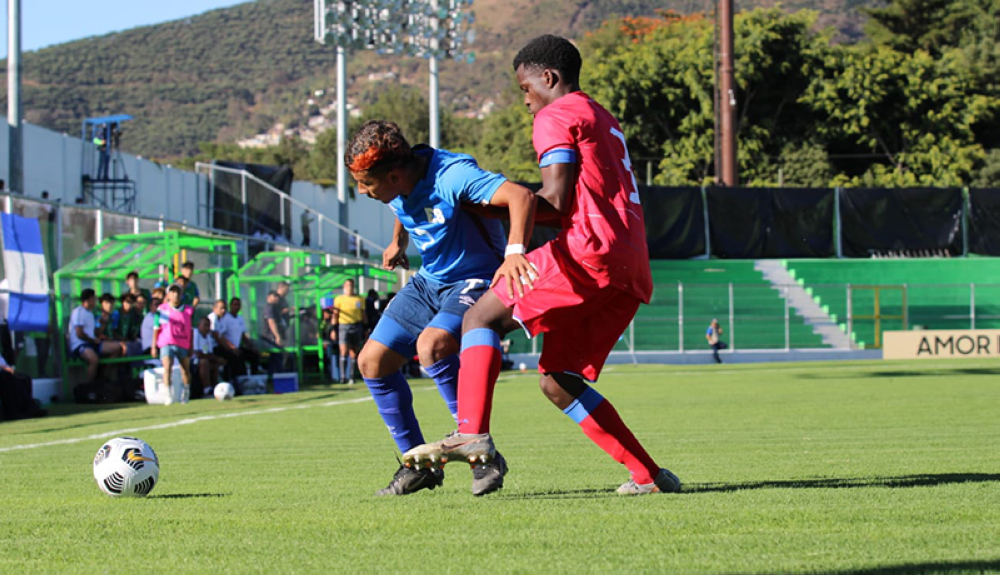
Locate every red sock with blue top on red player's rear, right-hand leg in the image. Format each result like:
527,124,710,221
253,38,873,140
563,387,660,484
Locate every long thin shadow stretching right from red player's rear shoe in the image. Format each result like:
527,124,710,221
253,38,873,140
684,473,1000,493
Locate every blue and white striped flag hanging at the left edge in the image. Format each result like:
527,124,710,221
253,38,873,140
0,214,49,331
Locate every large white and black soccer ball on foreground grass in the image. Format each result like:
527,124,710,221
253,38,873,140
94,437,160,497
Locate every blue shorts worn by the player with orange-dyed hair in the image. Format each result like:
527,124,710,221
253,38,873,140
371,274,490,357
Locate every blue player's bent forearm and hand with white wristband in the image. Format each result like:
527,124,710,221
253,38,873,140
490,181,538,298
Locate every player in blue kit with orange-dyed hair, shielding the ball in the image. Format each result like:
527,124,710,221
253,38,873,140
344,120,537,495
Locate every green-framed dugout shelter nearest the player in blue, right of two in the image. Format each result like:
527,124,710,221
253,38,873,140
228,251,399,388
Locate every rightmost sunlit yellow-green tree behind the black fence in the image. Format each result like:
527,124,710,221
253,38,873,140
803,45,997,186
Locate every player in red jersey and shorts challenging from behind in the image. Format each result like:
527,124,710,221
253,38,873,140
403,35,681,495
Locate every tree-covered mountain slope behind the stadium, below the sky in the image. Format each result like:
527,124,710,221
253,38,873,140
0,0,872,158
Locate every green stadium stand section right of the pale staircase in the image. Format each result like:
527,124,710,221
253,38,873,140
783,258,1000,347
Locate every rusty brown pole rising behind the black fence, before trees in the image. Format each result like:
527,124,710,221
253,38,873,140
716,0,739,187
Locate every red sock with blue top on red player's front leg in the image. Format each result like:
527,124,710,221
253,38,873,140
458,328,503,433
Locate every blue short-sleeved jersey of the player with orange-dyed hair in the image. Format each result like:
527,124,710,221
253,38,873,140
389,146,507,283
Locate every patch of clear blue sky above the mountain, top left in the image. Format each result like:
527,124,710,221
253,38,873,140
0,0,247,58
